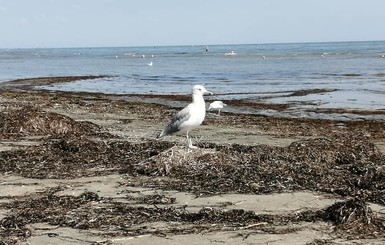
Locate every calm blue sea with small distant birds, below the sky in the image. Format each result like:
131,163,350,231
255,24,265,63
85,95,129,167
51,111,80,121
0,41,385,114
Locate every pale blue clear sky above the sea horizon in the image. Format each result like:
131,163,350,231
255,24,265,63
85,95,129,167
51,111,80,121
0,0,385,48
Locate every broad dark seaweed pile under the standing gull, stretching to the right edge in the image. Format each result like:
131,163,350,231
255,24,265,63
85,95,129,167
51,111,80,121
126,137,385,205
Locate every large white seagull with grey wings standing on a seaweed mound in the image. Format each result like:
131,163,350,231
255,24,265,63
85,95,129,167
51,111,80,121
157,85,213,149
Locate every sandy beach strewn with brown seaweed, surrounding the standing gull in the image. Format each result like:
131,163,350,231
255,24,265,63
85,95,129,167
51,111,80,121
0,76,385,245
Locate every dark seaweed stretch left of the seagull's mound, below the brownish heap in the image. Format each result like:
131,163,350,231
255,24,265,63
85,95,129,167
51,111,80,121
0,135,170,178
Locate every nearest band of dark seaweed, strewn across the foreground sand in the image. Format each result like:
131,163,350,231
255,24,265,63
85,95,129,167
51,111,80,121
0,190,385,244
